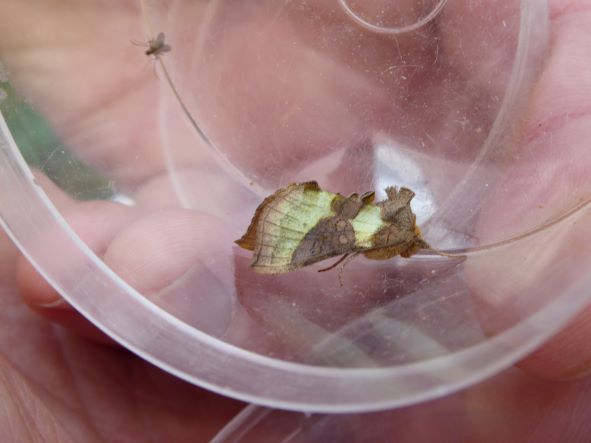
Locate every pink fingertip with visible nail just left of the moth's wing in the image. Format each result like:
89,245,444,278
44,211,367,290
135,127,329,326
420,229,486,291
105,210,238,335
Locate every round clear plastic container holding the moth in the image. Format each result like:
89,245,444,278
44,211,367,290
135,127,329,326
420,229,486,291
0,0,591,412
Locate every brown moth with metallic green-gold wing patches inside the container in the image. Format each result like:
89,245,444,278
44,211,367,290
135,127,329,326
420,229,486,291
236,181,446,274
